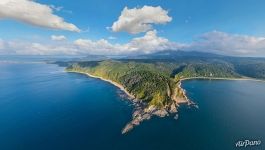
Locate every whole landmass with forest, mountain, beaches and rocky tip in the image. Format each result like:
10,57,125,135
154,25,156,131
62,51,265,133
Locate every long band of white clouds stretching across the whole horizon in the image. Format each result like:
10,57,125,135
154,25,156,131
0,30,265,57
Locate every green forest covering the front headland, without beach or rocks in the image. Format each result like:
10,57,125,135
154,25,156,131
67,61,176,107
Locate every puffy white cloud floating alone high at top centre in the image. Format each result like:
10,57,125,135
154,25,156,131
111,6,172,34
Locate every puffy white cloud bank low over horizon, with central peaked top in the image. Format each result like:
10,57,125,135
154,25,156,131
74,30,178,54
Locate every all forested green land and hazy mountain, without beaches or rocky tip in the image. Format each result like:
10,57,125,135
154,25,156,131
64,52,265,107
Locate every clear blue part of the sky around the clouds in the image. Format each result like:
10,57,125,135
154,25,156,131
0,0,265,54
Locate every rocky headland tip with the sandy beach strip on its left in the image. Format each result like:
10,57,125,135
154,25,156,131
66,71,197,134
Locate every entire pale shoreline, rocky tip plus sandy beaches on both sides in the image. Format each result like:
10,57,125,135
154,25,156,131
66,70,265,134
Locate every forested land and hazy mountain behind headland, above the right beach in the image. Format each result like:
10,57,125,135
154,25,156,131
126,51,265,79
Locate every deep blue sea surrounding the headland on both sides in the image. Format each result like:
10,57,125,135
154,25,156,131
0,58,265,150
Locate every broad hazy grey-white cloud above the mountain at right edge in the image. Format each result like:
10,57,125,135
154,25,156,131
186,31,265,56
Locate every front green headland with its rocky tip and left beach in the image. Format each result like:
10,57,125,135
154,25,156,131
66,60,193,133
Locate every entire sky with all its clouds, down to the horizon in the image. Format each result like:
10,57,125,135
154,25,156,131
0,0,265,57
